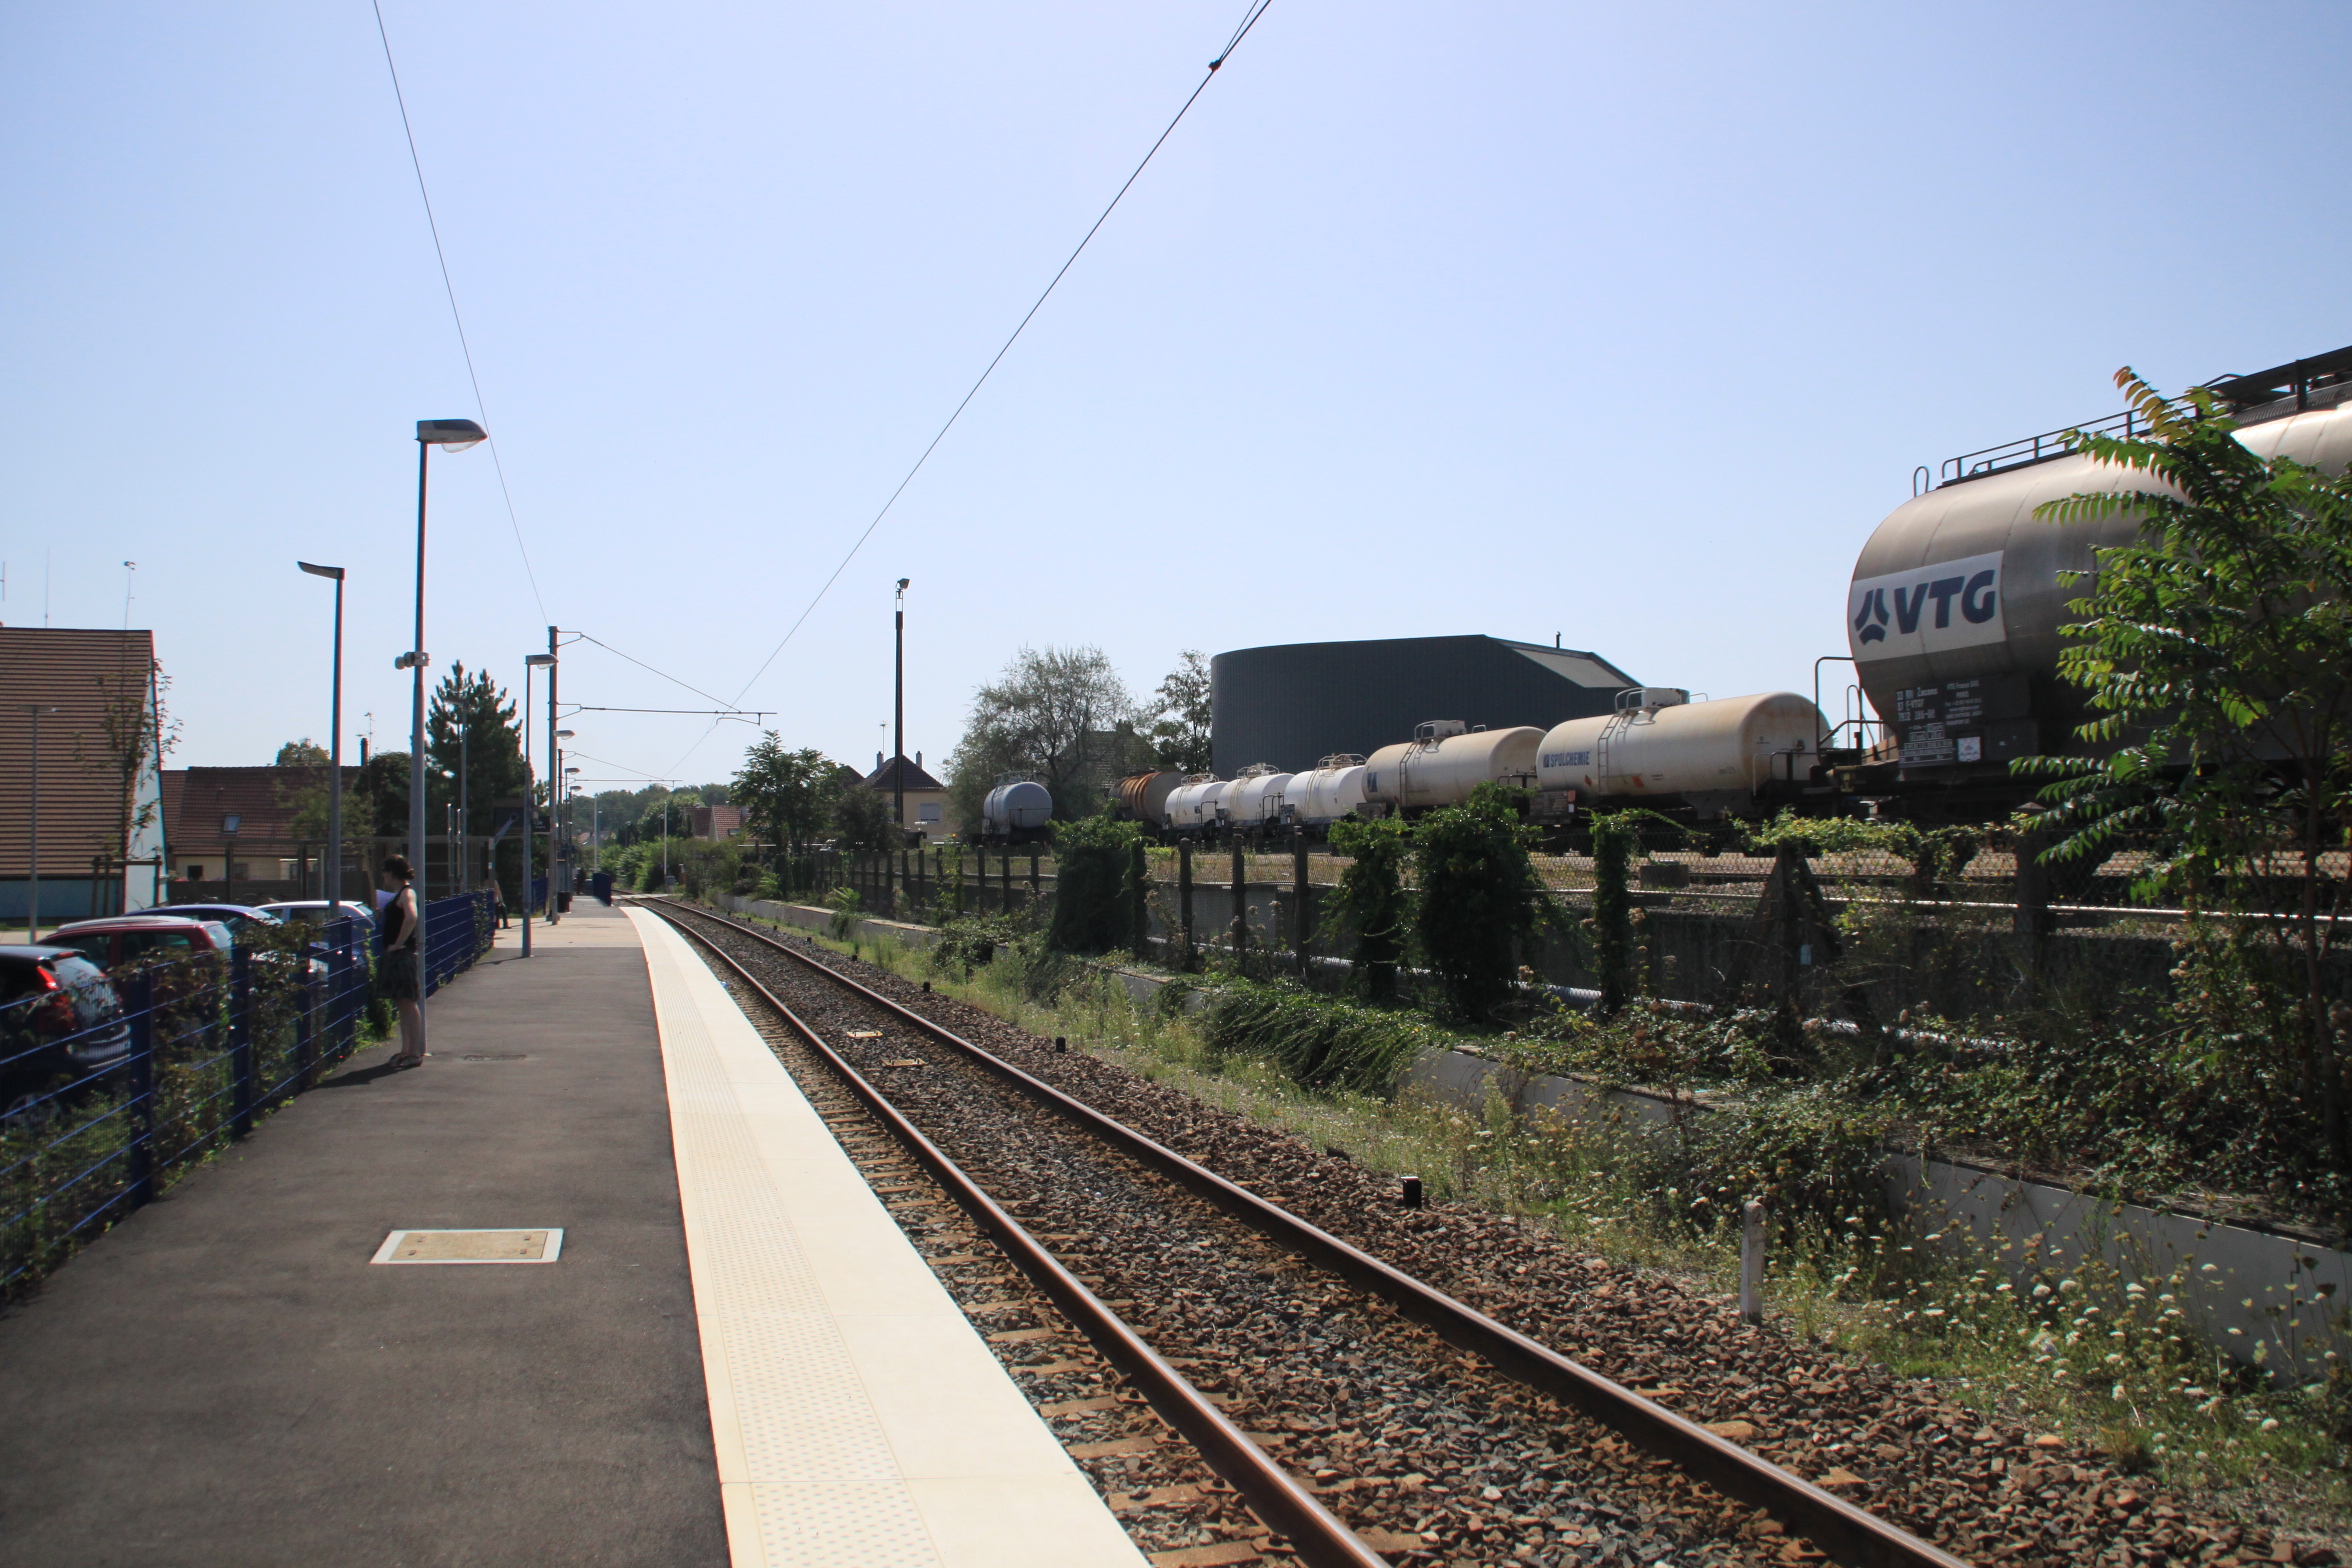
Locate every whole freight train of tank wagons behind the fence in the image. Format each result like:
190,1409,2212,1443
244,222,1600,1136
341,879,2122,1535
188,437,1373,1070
1120,348,2352,842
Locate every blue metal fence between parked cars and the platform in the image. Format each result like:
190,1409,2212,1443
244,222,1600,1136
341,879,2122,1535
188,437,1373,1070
0,893,496,1298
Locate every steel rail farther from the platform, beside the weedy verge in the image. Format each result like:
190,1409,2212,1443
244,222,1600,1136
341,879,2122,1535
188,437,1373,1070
666,900,1969,1568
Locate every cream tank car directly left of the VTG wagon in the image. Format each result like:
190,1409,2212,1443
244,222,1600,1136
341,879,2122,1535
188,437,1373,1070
1536,686,1828,816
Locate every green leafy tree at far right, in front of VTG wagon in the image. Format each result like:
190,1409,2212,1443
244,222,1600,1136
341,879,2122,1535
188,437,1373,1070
2018,367,2352,1168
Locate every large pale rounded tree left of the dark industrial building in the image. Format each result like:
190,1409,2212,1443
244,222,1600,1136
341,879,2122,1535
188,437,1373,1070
948,646,1141,832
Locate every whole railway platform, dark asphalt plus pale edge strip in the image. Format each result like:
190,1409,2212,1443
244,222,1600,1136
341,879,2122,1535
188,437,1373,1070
0,903,1141,1568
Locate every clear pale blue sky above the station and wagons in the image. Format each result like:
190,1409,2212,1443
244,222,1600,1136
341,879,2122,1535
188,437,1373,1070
0,0,2352,780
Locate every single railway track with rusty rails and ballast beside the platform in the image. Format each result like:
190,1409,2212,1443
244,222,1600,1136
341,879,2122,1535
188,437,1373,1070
649,900,1962,1568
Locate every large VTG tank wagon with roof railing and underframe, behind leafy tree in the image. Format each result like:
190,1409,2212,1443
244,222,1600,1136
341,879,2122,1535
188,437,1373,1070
1830,348,2352,818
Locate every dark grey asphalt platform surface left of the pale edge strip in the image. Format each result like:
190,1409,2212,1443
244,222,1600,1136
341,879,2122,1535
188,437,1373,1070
0,900,727,1568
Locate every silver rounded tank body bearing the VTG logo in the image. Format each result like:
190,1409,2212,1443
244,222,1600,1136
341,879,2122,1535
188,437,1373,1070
1846,388,2352,783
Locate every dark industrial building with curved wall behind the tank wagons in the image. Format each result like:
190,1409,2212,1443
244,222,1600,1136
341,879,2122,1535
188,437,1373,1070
1209,637,1639,778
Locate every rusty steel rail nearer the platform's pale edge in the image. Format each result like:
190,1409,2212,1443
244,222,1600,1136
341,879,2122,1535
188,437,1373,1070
661,910,1390,1568
